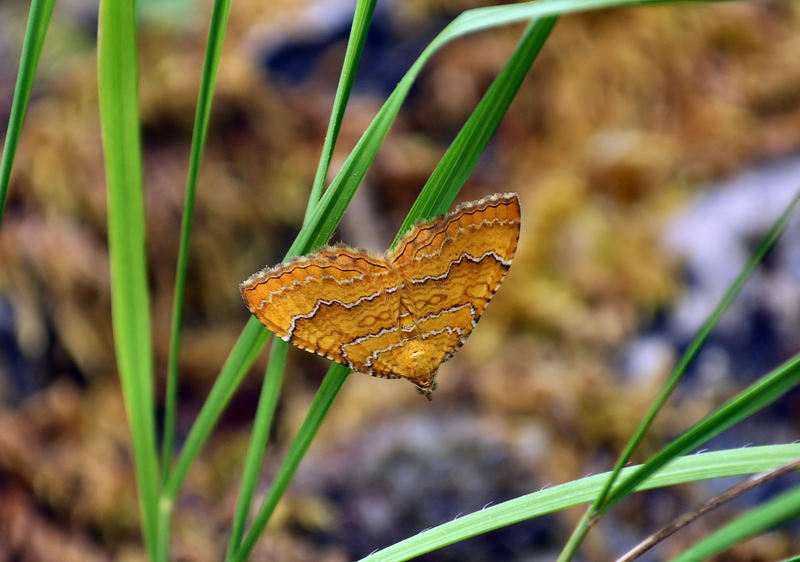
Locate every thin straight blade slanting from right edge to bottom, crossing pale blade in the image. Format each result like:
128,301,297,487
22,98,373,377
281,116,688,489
559,191,800,561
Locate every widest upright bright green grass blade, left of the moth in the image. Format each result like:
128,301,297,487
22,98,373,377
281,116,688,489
97,0,159,559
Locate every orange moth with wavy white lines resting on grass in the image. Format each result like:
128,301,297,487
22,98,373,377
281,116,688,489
240,193,520,397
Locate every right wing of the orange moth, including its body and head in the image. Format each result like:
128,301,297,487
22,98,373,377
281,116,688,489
371,190,520,388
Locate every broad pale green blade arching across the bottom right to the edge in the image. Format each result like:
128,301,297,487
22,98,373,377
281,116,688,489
363,444,800,562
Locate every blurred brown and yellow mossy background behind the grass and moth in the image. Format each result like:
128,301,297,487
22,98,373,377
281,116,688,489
0,0,800,561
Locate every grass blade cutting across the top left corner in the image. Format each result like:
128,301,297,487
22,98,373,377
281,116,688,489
0,0,55,224
